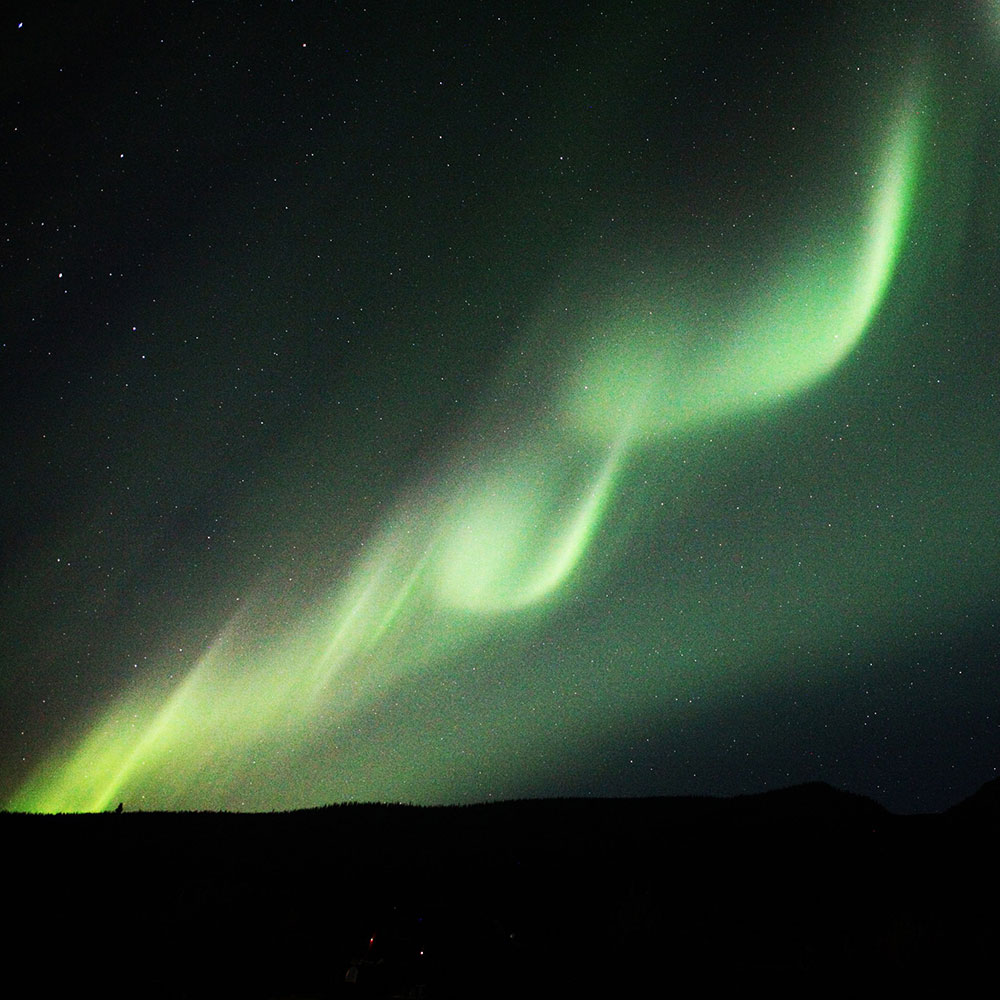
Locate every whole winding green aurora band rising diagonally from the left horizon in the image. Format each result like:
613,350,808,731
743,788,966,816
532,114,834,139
9,82,921,812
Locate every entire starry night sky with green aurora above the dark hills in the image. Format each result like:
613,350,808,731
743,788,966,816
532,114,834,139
0,0,1000,812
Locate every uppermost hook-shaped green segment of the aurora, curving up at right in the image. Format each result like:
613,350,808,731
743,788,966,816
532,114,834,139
563,93,921,438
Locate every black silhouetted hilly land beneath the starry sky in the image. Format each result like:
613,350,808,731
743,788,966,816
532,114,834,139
0,783,1000,998
